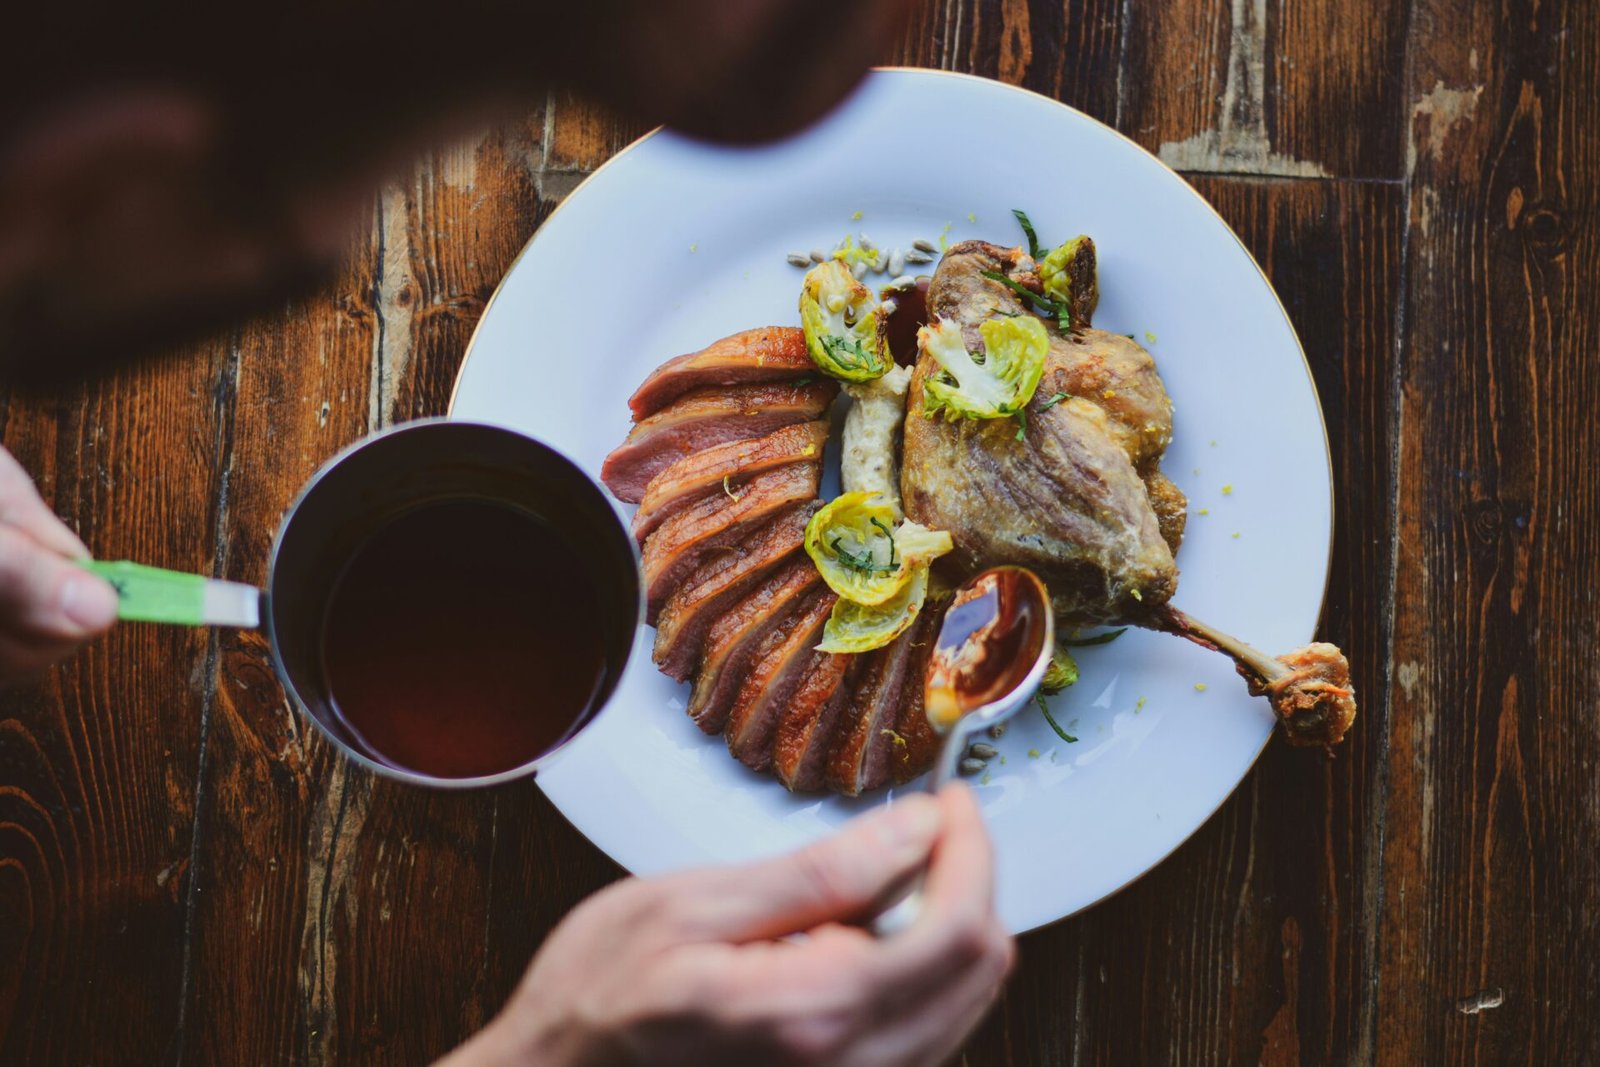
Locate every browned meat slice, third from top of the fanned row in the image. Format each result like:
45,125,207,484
634,419,827,544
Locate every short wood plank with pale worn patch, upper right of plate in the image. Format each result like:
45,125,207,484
1122,0,1408,179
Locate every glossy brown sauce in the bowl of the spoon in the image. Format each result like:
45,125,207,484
925,566,1050,733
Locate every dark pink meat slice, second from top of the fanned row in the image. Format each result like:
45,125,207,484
600,378,838,504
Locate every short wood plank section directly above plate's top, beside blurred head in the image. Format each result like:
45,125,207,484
894,0,1123,123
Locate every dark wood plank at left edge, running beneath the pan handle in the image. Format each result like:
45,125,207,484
0,339,232,1064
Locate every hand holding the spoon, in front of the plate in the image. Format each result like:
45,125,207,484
442,784,1014,1067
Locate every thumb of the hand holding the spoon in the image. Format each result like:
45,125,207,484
670,793,941,942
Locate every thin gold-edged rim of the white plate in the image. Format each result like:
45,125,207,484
443,64,1338,934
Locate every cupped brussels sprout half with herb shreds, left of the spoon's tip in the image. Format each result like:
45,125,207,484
805,493,954,608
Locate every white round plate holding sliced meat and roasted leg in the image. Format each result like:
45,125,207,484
451,70,1331,931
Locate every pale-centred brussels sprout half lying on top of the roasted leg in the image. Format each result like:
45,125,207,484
917,315,1050,422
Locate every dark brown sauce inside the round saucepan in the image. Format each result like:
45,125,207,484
323,499,606,777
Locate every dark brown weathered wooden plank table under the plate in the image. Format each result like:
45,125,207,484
0,0,1600,1064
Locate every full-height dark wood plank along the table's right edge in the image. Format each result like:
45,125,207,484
1378,0,1600,1064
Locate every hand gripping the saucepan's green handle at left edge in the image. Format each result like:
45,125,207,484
0,448,117,681
